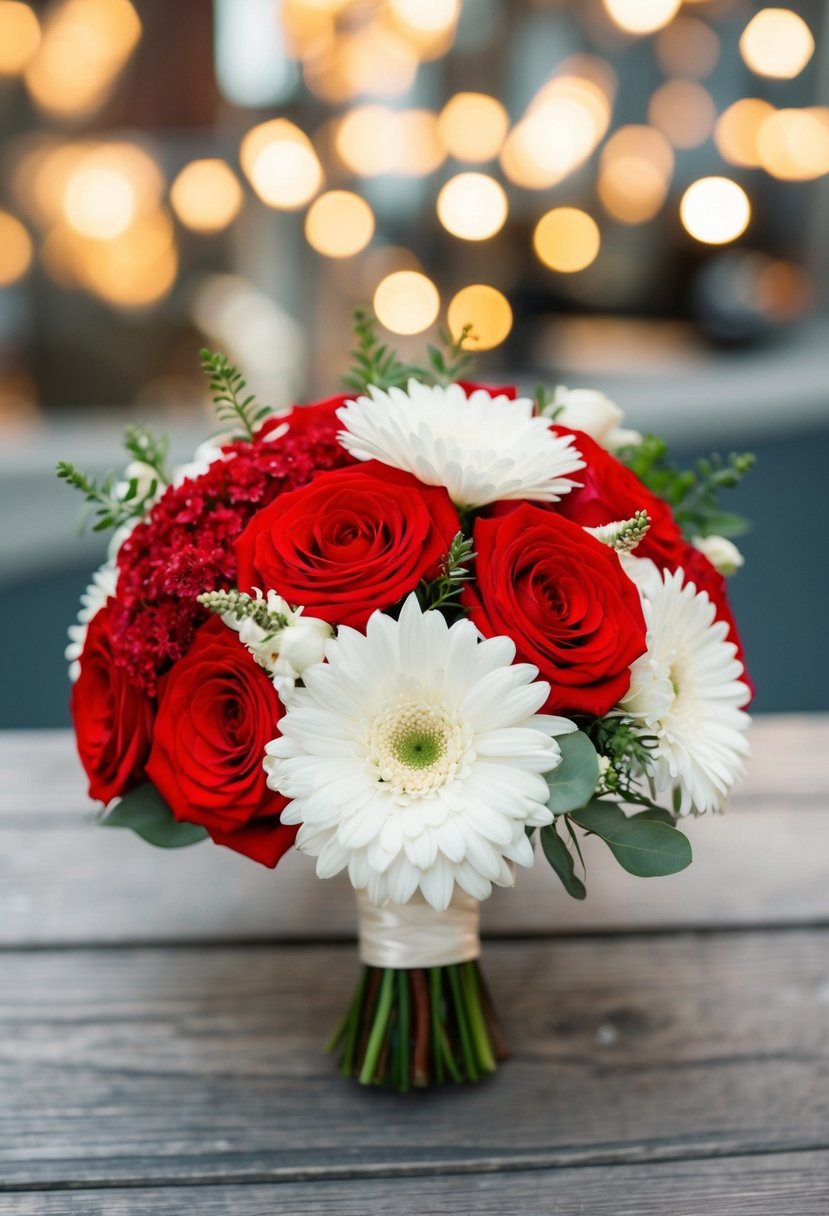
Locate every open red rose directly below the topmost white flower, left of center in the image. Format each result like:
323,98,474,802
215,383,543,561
236,461,461,629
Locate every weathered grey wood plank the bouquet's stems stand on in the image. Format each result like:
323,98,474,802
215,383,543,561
0,930,829,1189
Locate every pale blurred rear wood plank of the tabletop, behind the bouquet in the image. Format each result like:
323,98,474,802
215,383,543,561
0,716,829,946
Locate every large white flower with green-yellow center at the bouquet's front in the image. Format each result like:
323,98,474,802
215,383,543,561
265,596,575,910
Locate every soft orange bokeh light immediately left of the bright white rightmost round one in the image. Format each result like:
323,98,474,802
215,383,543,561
598,125,673,224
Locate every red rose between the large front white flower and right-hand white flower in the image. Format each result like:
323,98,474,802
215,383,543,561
462,502,645,716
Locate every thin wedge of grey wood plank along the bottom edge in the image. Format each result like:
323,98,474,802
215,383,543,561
0,1153,829,1216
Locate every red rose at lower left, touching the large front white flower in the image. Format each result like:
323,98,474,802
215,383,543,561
147,617,297,866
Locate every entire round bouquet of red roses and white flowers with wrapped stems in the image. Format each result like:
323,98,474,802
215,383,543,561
58,315,751,1090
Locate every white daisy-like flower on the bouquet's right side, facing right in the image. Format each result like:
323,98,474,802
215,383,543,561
620,557,750,815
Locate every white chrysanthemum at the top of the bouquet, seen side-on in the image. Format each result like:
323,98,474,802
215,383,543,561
337,379,585,507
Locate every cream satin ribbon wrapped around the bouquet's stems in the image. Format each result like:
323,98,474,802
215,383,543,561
355,886,480,970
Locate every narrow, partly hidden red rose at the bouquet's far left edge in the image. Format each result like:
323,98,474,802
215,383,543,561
72,601,154,803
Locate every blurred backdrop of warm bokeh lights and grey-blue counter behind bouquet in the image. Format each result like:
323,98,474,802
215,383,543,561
0,0,829,726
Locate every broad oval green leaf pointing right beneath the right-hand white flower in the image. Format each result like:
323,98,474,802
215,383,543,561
571,801,692,878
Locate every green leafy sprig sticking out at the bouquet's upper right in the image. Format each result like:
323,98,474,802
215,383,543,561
616,434,755,540
